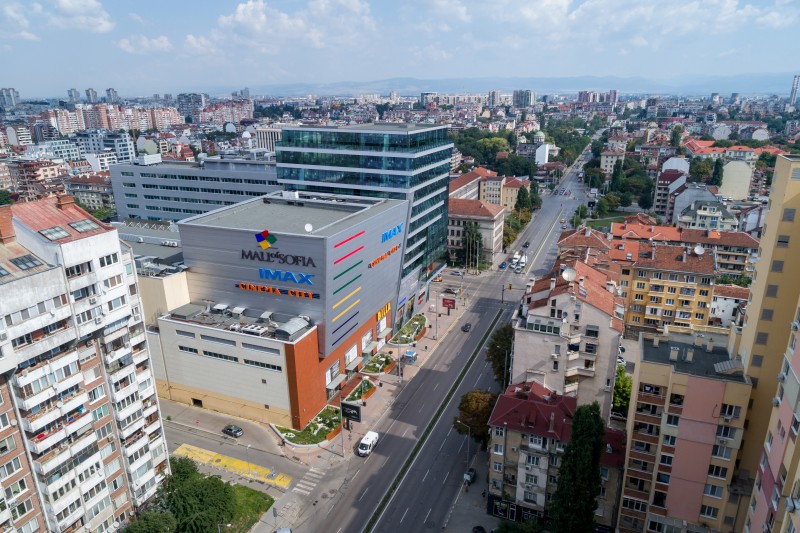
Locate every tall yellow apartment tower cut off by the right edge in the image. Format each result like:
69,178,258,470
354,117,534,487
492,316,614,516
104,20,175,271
737,155,800,531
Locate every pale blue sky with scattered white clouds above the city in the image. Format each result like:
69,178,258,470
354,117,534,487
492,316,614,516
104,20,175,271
0,0,800,98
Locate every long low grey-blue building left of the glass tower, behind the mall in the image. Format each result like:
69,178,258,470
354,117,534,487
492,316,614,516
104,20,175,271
110,154,282,221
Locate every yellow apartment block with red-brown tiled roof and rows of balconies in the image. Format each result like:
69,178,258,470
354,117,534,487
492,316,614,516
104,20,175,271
621,243,717,332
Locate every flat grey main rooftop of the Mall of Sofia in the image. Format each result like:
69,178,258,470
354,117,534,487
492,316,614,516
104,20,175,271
180,191,406,237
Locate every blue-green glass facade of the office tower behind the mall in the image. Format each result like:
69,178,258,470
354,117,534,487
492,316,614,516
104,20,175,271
276,124,453,277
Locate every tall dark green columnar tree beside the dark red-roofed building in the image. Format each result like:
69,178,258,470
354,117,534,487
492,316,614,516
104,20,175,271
550,402,605,533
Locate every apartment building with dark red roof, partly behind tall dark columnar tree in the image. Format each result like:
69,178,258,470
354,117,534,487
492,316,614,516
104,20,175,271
487,381,625,528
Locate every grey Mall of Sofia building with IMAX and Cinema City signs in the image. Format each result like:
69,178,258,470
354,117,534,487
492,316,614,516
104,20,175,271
145,191,409,429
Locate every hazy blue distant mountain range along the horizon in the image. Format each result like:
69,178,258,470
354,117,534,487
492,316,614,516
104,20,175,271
241,73,793,96
